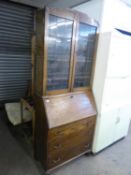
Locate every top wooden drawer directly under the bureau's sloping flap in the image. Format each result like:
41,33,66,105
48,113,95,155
48,116,96,141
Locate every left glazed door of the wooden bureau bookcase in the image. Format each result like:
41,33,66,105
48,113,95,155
46,8,75,94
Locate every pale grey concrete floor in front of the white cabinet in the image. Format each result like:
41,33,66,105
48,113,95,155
52,127,131,175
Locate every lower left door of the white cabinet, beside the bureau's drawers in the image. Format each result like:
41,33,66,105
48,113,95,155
92,110,117,153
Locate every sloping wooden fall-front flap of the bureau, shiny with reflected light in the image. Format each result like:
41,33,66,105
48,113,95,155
43,91,96,128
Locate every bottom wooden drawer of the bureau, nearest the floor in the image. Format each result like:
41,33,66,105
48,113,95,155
48,141,91,169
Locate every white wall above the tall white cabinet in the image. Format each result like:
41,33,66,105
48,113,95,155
73,0,131,32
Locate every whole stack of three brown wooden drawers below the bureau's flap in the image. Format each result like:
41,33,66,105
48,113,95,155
48,117,95,169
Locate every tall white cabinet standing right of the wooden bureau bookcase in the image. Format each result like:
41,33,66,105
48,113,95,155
92,30,131,153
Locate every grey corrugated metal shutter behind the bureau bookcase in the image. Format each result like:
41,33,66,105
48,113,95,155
0,1,34,101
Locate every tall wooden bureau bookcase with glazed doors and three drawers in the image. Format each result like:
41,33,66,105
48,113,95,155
35,8,97,171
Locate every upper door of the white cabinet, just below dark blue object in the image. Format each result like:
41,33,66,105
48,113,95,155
107,33,131,77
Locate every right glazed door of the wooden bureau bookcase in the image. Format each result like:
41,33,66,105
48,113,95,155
73,20,96,90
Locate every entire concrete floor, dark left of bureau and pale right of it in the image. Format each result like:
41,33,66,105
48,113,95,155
0,108,131,175
